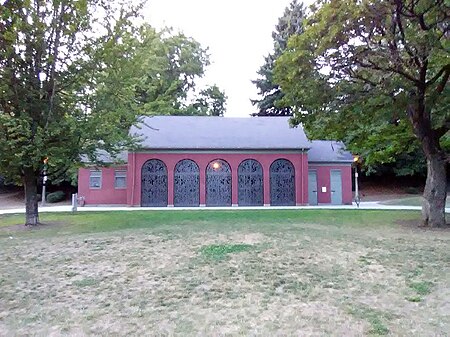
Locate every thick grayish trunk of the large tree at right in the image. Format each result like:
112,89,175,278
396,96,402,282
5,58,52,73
422,155,447,227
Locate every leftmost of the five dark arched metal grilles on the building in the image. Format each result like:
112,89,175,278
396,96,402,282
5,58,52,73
141,159,167,207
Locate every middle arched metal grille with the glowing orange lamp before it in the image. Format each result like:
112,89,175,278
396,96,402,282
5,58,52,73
206,159,231,206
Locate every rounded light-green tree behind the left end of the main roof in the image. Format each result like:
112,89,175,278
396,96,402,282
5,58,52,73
131,26,209,115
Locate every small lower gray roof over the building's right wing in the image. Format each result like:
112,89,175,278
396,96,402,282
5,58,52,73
308,140,353,163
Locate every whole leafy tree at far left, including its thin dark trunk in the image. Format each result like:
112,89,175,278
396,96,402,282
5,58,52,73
0,0,148,225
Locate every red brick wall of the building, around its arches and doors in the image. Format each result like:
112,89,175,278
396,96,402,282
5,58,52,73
78,153,352,206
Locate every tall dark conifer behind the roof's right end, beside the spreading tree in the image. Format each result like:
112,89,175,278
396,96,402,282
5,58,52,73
252,0,305,116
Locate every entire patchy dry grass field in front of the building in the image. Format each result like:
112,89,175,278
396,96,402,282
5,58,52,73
0,210,450,336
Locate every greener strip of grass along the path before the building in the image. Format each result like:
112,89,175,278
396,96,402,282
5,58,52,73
0,209,426,236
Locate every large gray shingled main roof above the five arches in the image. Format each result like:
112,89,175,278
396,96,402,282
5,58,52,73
130,116,311,150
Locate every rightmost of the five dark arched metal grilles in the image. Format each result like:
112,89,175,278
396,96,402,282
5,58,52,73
270,159,295,206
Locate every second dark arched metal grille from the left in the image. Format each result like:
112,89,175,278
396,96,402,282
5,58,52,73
173,159,200,206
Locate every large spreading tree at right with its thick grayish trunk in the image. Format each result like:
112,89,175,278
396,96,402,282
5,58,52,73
275,0,450,226
